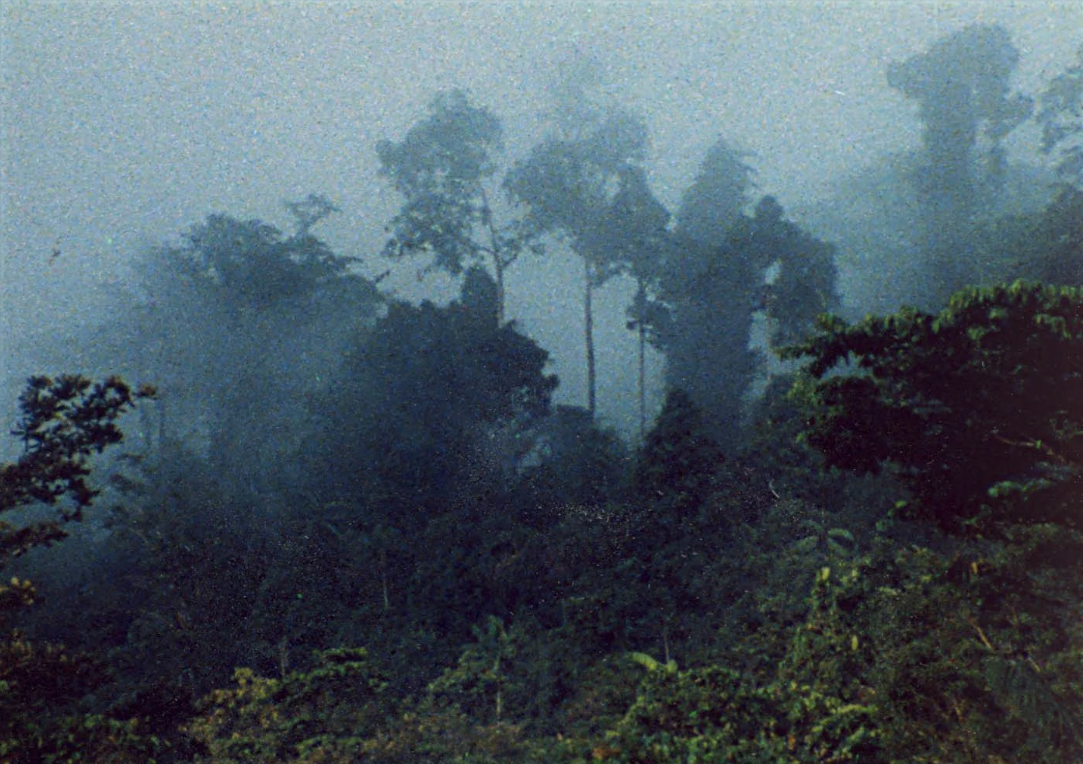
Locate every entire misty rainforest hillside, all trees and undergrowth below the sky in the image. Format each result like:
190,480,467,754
0,26,1083,764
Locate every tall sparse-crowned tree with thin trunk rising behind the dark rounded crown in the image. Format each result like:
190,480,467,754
376,90,527,322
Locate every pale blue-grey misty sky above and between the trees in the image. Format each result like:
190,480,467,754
0,0,1083,429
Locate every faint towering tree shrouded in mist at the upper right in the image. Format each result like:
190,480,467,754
887,25,1033,305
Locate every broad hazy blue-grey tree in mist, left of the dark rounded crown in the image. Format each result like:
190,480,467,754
108,195,381,492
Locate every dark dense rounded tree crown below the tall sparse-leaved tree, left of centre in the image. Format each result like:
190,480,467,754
312,281,557,523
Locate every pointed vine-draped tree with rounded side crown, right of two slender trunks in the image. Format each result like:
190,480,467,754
649,140,838,449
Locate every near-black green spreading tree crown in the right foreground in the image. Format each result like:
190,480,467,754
787,283,1083,533
